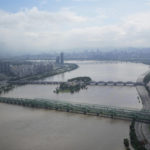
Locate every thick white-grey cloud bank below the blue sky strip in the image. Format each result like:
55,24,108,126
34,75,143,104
0,1,150,54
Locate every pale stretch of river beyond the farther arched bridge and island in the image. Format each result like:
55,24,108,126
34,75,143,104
44,61,148,81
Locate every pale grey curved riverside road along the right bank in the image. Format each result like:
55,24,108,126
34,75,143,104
135,71,150,150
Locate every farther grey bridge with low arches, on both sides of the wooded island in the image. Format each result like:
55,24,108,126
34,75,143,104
9,81,144,86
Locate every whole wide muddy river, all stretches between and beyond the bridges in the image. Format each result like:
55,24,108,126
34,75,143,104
0,61,148,150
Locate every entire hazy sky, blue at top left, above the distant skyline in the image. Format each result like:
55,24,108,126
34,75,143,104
0,0,150,52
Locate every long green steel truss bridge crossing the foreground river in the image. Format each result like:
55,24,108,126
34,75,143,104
0,97,150,123
